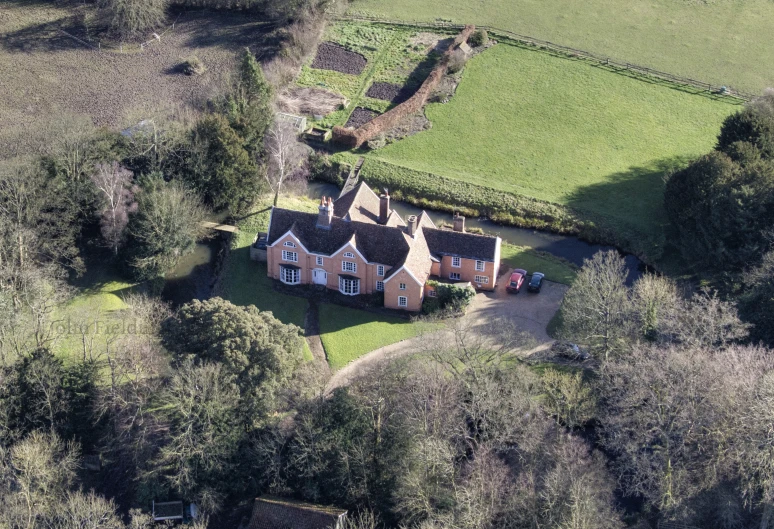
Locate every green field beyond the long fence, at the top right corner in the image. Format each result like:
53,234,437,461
349,0,774,93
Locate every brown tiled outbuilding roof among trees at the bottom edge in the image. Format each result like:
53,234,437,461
249,496,347,529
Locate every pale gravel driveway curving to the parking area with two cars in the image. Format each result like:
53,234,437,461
326,269,569,392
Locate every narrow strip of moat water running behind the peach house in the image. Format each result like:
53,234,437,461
307,182,645,284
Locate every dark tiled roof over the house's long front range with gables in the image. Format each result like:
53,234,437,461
268,208,409,266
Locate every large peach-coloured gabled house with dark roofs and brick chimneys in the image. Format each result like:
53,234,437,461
267,182,502,311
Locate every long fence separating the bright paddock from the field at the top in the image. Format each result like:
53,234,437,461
338,15,758,101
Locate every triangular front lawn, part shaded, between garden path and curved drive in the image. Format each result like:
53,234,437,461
320,305,423,369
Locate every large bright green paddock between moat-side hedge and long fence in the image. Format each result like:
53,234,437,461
366,43,738,243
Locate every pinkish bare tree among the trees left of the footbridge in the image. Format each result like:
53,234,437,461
91,162,137,254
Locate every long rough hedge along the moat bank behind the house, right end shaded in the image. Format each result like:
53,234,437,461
360,157,664,264
